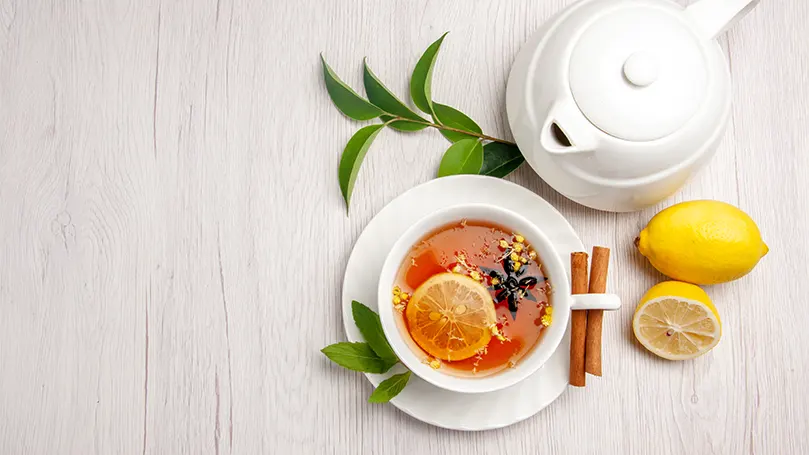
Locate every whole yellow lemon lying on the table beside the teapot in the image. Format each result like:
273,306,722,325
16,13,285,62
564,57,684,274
635,200,769,284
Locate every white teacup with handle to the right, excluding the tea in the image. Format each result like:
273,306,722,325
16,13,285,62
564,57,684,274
378,204,621,393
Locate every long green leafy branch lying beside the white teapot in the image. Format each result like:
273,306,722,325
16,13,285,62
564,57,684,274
320,33,525,213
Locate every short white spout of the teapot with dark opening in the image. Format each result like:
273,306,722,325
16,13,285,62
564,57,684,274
539,98,598,155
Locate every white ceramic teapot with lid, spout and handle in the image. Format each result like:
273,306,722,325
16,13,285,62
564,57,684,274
506,0,759,212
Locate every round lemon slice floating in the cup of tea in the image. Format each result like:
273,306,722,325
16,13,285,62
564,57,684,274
405,273,497,360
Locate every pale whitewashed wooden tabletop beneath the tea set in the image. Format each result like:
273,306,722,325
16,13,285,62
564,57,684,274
0,0,809,454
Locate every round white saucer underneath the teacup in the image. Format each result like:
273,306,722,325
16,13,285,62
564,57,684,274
343,175,584,431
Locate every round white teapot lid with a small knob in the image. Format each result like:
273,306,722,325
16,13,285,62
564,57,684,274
569,4,708,142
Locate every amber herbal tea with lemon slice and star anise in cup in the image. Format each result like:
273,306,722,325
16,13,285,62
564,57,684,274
392,220,553,377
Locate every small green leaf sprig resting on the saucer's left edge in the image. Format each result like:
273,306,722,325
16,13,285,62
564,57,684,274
321,302,410,403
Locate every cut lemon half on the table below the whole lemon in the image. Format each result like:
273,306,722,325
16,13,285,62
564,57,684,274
632,281,722,360
